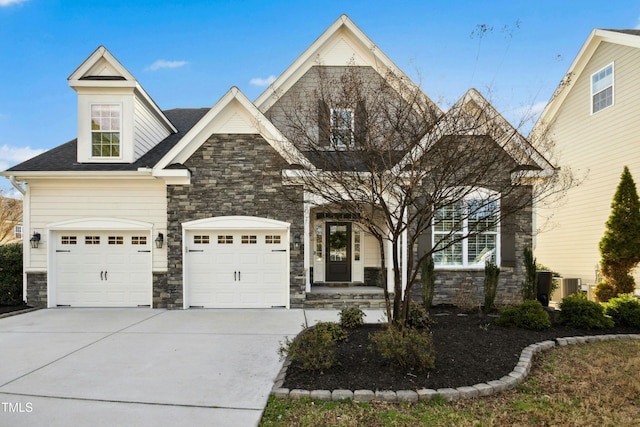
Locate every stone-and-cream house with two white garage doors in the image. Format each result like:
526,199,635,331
3,15,553,309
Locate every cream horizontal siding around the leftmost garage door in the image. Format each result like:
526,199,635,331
25,179,167,271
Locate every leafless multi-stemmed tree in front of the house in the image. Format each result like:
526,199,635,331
268,65,571,322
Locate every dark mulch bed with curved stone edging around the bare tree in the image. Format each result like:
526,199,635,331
283,308,640,390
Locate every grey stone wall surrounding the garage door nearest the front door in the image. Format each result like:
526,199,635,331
165,134,306,308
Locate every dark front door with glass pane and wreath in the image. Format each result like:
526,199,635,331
325,222,351,282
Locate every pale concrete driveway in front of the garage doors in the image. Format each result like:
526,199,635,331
0,308,314,427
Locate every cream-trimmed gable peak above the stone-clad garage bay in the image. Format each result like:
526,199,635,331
154,87,313,174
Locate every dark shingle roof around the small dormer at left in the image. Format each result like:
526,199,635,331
7,108,209,172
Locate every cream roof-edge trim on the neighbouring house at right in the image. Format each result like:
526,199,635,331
531,28,640,135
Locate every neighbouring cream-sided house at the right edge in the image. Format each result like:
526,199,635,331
533,29,640,298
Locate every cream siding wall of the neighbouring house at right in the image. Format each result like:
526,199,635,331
535,43,640,283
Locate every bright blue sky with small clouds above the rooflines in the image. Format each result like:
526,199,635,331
0,0,640,196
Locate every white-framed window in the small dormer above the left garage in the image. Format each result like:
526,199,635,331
91,104,122,157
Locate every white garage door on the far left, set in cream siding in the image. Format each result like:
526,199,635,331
53,230,152,307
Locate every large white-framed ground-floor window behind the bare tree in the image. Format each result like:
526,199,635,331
432,197,500,267
